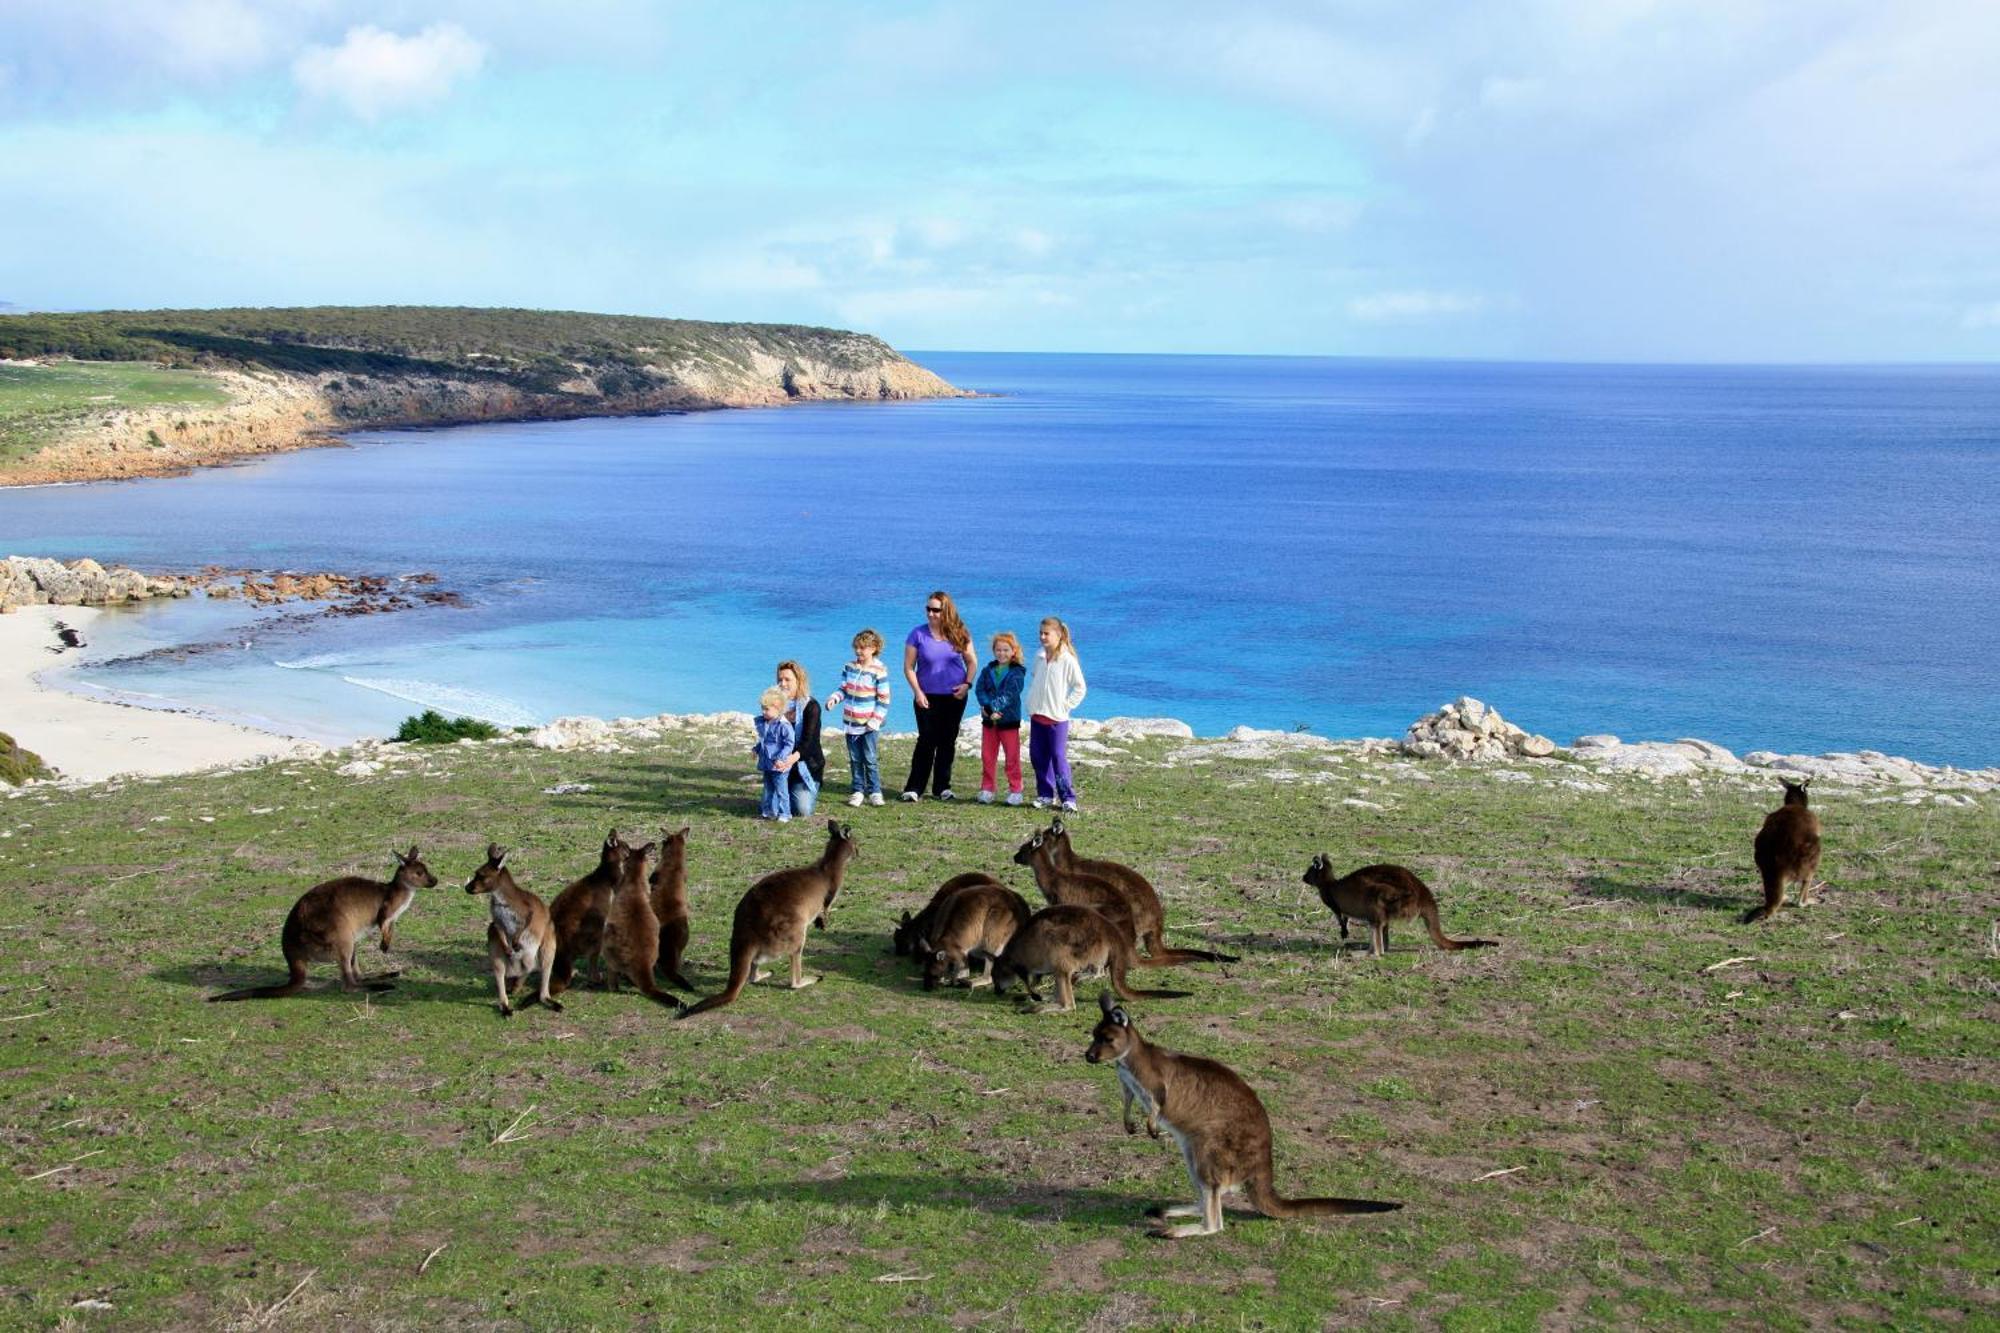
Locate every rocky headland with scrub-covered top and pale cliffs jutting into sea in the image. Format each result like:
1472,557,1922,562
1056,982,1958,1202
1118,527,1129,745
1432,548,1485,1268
0,306,964,484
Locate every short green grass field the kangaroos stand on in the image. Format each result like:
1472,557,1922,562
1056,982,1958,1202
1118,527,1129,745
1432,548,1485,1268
0,733,2000,1329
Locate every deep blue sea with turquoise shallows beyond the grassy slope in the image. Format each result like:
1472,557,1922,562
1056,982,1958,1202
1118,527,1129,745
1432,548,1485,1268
0,352,2000,765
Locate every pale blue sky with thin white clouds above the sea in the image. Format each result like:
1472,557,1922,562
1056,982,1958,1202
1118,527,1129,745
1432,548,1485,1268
0,0,2000,360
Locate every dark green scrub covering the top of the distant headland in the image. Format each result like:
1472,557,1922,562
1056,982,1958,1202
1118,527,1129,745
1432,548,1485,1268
0,306,920,394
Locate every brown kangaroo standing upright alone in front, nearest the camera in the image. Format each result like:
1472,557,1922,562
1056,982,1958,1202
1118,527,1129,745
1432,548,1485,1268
1084,995,1402,1241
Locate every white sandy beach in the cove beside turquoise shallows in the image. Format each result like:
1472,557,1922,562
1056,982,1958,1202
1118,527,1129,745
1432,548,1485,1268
0,606,318,783
